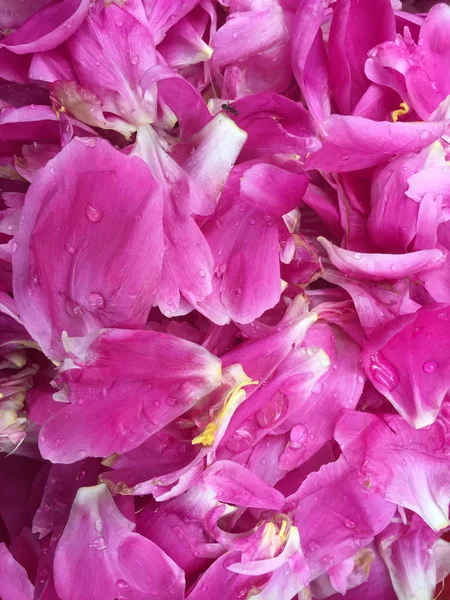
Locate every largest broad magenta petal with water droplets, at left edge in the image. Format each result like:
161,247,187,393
13,138,162,357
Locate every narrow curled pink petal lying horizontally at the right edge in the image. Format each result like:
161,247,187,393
319,237,445,281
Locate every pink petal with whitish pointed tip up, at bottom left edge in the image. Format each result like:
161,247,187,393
54,484,184,600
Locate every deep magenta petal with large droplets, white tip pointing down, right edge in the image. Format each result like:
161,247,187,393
362,305,450,428
